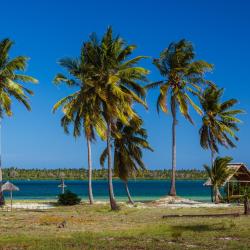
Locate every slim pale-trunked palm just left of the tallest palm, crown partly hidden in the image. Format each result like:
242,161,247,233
53,46,106,204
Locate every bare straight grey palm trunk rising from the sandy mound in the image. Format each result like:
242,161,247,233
169,98,177,196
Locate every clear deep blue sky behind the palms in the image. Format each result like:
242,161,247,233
0,0,250,169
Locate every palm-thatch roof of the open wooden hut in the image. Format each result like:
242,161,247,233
203,163,250,186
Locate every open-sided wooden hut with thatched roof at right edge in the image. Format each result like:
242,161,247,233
203,163,250,201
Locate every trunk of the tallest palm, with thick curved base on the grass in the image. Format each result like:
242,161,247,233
107,122,119,210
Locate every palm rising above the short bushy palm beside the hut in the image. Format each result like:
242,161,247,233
199,86,243,163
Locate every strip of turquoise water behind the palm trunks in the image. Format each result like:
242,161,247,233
2,180,210,201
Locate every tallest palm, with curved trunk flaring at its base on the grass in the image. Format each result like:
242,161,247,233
81,27,149,210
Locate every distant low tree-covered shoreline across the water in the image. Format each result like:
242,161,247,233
3,167,207,180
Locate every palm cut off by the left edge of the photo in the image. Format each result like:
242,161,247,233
0,38,37,205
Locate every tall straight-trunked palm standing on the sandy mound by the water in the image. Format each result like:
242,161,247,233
147,39,212,196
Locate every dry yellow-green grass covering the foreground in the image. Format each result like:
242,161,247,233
0,204,250,250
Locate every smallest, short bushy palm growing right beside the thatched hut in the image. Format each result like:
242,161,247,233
204,157,232,203
